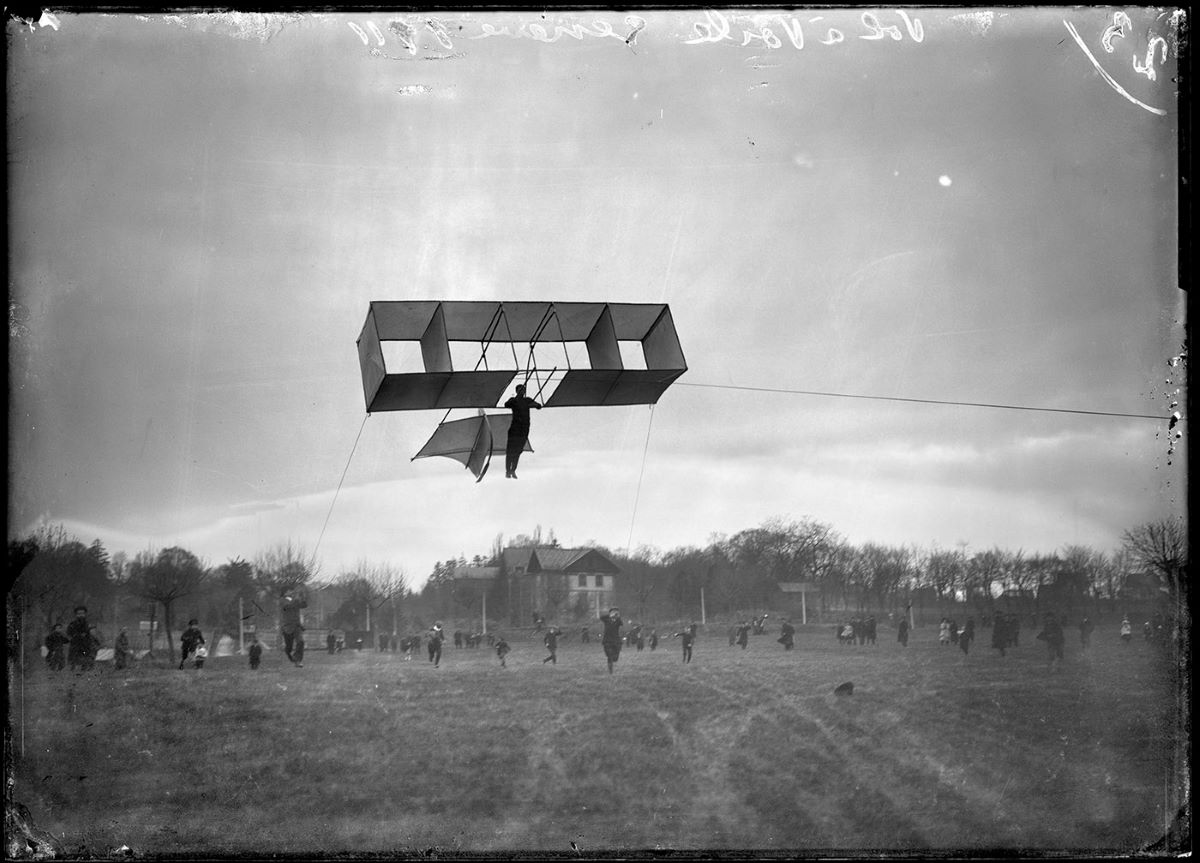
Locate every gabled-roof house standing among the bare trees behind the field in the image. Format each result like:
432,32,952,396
500,546,620,624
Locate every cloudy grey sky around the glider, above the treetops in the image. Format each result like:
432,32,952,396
6,7,1188,595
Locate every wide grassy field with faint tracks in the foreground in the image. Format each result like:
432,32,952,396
10,627,1188,857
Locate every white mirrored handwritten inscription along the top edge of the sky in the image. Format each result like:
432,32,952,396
348,10,925,56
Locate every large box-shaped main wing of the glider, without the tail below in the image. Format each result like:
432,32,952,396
358,300,688,413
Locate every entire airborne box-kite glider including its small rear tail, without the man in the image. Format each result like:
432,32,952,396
358,300,688,481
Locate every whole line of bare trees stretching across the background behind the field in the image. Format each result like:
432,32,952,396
7,517,1188,661
